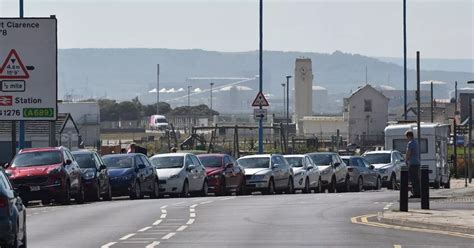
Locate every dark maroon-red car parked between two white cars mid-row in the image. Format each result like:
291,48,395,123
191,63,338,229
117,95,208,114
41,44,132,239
198,154,245,195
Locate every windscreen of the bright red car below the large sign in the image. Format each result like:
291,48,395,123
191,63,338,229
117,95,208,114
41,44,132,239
12,151,63,167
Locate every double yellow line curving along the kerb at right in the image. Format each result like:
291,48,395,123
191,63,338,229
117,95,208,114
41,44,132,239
351,214,474,239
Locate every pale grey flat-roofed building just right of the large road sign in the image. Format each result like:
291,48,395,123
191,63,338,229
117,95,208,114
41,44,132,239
58,102,100,146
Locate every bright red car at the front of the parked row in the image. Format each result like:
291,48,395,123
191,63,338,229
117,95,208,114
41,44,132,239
6,147,84,205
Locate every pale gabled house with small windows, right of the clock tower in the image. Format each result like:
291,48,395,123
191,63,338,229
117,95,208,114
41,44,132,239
345,84,389,145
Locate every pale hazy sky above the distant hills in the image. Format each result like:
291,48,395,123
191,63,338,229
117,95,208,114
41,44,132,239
0,0,474,59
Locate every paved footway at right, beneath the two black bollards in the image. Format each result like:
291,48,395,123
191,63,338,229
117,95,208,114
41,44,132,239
376,180,474,237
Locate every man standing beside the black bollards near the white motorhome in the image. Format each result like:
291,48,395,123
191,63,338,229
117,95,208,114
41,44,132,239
405,131,421,198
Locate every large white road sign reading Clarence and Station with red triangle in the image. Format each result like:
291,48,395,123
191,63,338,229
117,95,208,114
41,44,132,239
0,17,58,120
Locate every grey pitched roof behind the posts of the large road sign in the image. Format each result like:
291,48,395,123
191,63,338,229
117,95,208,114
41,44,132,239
0,113,79,135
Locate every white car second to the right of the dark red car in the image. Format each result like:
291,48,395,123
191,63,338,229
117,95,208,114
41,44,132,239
284,155,323,193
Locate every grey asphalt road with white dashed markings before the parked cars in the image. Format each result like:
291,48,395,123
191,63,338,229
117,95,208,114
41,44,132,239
27,190,474,248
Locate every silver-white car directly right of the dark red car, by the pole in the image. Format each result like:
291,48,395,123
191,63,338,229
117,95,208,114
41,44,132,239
237,154,295,194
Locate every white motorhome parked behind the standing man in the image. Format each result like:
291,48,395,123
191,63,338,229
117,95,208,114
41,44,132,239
385,123,450,188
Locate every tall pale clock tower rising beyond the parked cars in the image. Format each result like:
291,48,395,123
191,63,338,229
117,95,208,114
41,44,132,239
293,58,313,134
